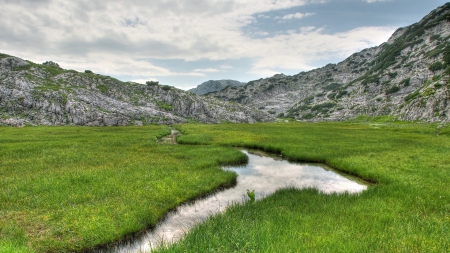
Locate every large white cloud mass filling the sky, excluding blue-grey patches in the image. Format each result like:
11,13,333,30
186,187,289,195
0,0,393,85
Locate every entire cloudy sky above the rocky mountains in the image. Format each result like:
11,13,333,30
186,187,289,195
0,0,446,89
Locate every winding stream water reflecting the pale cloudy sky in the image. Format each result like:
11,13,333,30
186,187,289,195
99,151,367,252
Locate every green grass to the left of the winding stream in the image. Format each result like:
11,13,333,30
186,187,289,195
0,126,247,252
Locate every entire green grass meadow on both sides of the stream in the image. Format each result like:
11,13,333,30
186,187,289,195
0,120,450,252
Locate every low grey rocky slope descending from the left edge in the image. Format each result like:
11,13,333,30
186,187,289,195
0,57,273,126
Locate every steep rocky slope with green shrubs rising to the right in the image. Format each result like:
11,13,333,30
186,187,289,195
208,3,450,122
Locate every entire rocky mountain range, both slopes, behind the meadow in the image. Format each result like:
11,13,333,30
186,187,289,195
0,3,450,126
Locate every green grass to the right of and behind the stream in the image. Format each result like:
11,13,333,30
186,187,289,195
153,122,450,252
